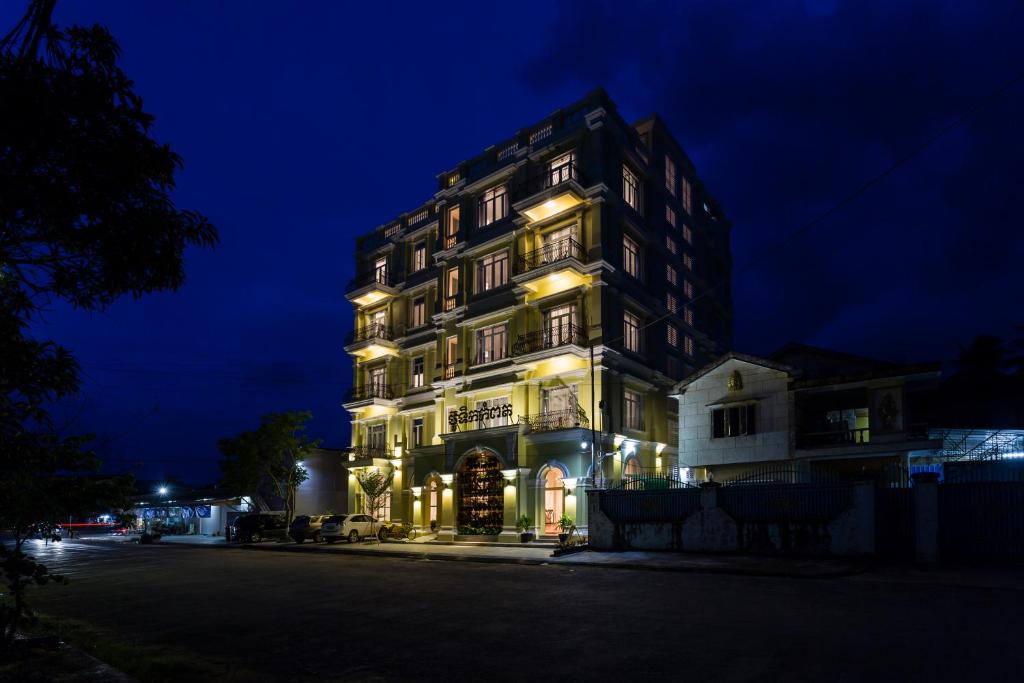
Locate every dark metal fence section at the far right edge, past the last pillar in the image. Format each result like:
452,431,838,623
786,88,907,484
938,480,1024,562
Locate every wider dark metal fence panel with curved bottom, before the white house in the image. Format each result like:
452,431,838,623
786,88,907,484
718,483,853,523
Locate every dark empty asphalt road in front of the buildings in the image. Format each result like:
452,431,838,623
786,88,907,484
18,541,1024,682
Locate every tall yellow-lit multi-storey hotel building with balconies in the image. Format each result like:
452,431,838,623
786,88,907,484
344,91,732,539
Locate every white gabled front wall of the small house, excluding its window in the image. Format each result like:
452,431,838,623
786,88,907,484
679,358,793,467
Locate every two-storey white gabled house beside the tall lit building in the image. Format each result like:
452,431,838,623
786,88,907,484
673,344,942,481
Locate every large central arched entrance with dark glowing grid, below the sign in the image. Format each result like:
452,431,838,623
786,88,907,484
456,451,505,536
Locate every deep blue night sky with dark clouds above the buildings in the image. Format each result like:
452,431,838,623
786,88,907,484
9,0,1024,482
